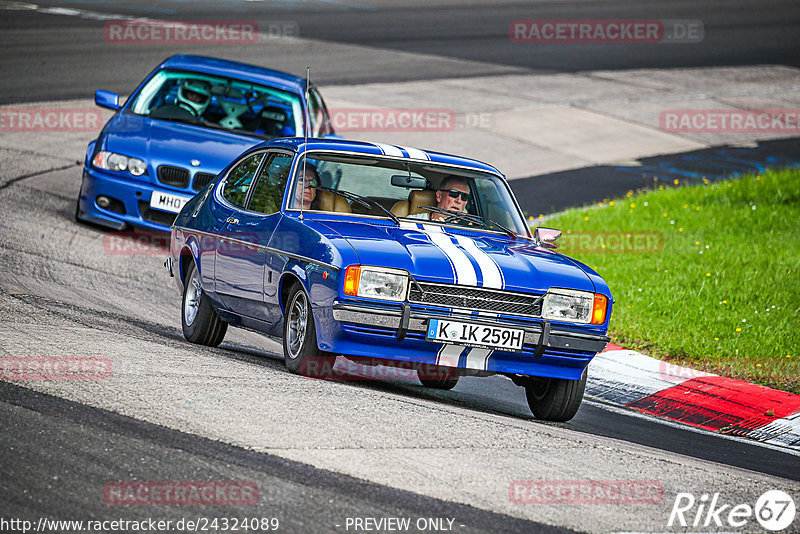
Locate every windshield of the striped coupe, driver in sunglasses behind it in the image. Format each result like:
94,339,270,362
288,152,529,236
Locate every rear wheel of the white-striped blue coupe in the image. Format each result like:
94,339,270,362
181,262,228,347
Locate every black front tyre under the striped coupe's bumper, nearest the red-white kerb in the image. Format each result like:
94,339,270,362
525,369,586,422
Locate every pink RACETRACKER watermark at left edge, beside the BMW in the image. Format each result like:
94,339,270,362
0,107,103,132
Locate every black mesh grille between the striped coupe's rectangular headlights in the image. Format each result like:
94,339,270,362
408,282,542,317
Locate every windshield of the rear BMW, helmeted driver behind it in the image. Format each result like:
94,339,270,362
130,70,303,139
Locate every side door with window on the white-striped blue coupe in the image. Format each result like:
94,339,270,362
217,150,292,323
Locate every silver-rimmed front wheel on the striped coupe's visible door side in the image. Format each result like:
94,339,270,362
283,284,336,378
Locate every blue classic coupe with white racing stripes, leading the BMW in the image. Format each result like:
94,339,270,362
167,138,612,421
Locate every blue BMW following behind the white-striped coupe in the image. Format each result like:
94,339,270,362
75,55,334,231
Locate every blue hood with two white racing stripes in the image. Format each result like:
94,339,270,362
312,220,595,293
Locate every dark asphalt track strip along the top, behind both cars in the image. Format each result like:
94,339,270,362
0,0,800,104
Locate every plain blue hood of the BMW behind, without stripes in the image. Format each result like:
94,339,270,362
100,114,263,176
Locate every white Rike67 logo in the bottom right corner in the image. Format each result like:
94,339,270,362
667,490,797,532
